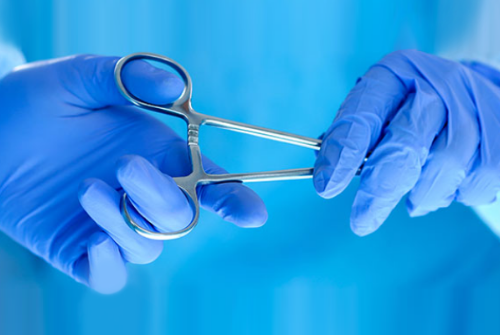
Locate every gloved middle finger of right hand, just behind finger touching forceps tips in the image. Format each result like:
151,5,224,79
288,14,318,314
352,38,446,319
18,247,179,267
351,84,446,235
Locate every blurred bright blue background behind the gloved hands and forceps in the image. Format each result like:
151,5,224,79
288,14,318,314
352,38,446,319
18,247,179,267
0,0,500,335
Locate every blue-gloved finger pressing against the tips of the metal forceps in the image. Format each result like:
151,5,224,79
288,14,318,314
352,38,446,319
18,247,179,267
314,65,408,198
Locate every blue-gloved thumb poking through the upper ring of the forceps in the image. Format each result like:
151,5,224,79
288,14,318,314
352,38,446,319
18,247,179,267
54,55,184,109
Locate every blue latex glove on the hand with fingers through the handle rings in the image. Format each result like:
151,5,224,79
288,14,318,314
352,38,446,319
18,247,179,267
0,56,267,293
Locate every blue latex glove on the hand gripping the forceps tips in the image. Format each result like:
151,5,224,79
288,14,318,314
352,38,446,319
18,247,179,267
314,50,500,235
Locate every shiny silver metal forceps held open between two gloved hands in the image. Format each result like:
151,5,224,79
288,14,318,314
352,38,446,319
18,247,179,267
114,53,321,240
